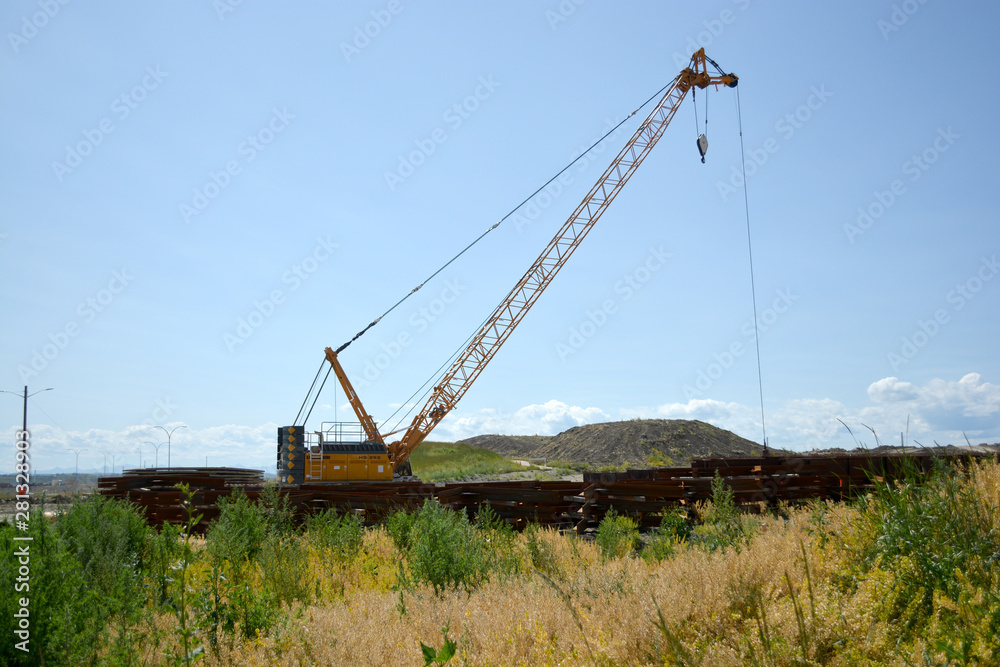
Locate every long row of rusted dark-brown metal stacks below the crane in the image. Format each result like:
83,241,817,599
98,453,983,532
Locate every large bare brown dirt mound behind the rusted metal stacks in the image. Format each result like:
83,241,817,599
462,419,761,468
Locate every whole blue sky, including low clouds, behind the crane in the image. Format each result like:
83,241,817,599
0,0,1000,472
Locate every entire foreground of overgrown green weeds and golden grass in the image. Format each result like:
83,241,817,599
0,452,1000,666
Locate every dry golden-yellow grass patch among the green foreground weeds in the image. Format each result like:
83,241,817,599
131,463,1000,666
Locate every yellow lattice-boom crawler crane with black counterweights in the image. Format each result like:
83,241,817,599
278,49,738,484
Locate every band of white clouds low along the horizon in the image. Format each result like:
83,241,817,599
9,373,1000,473
